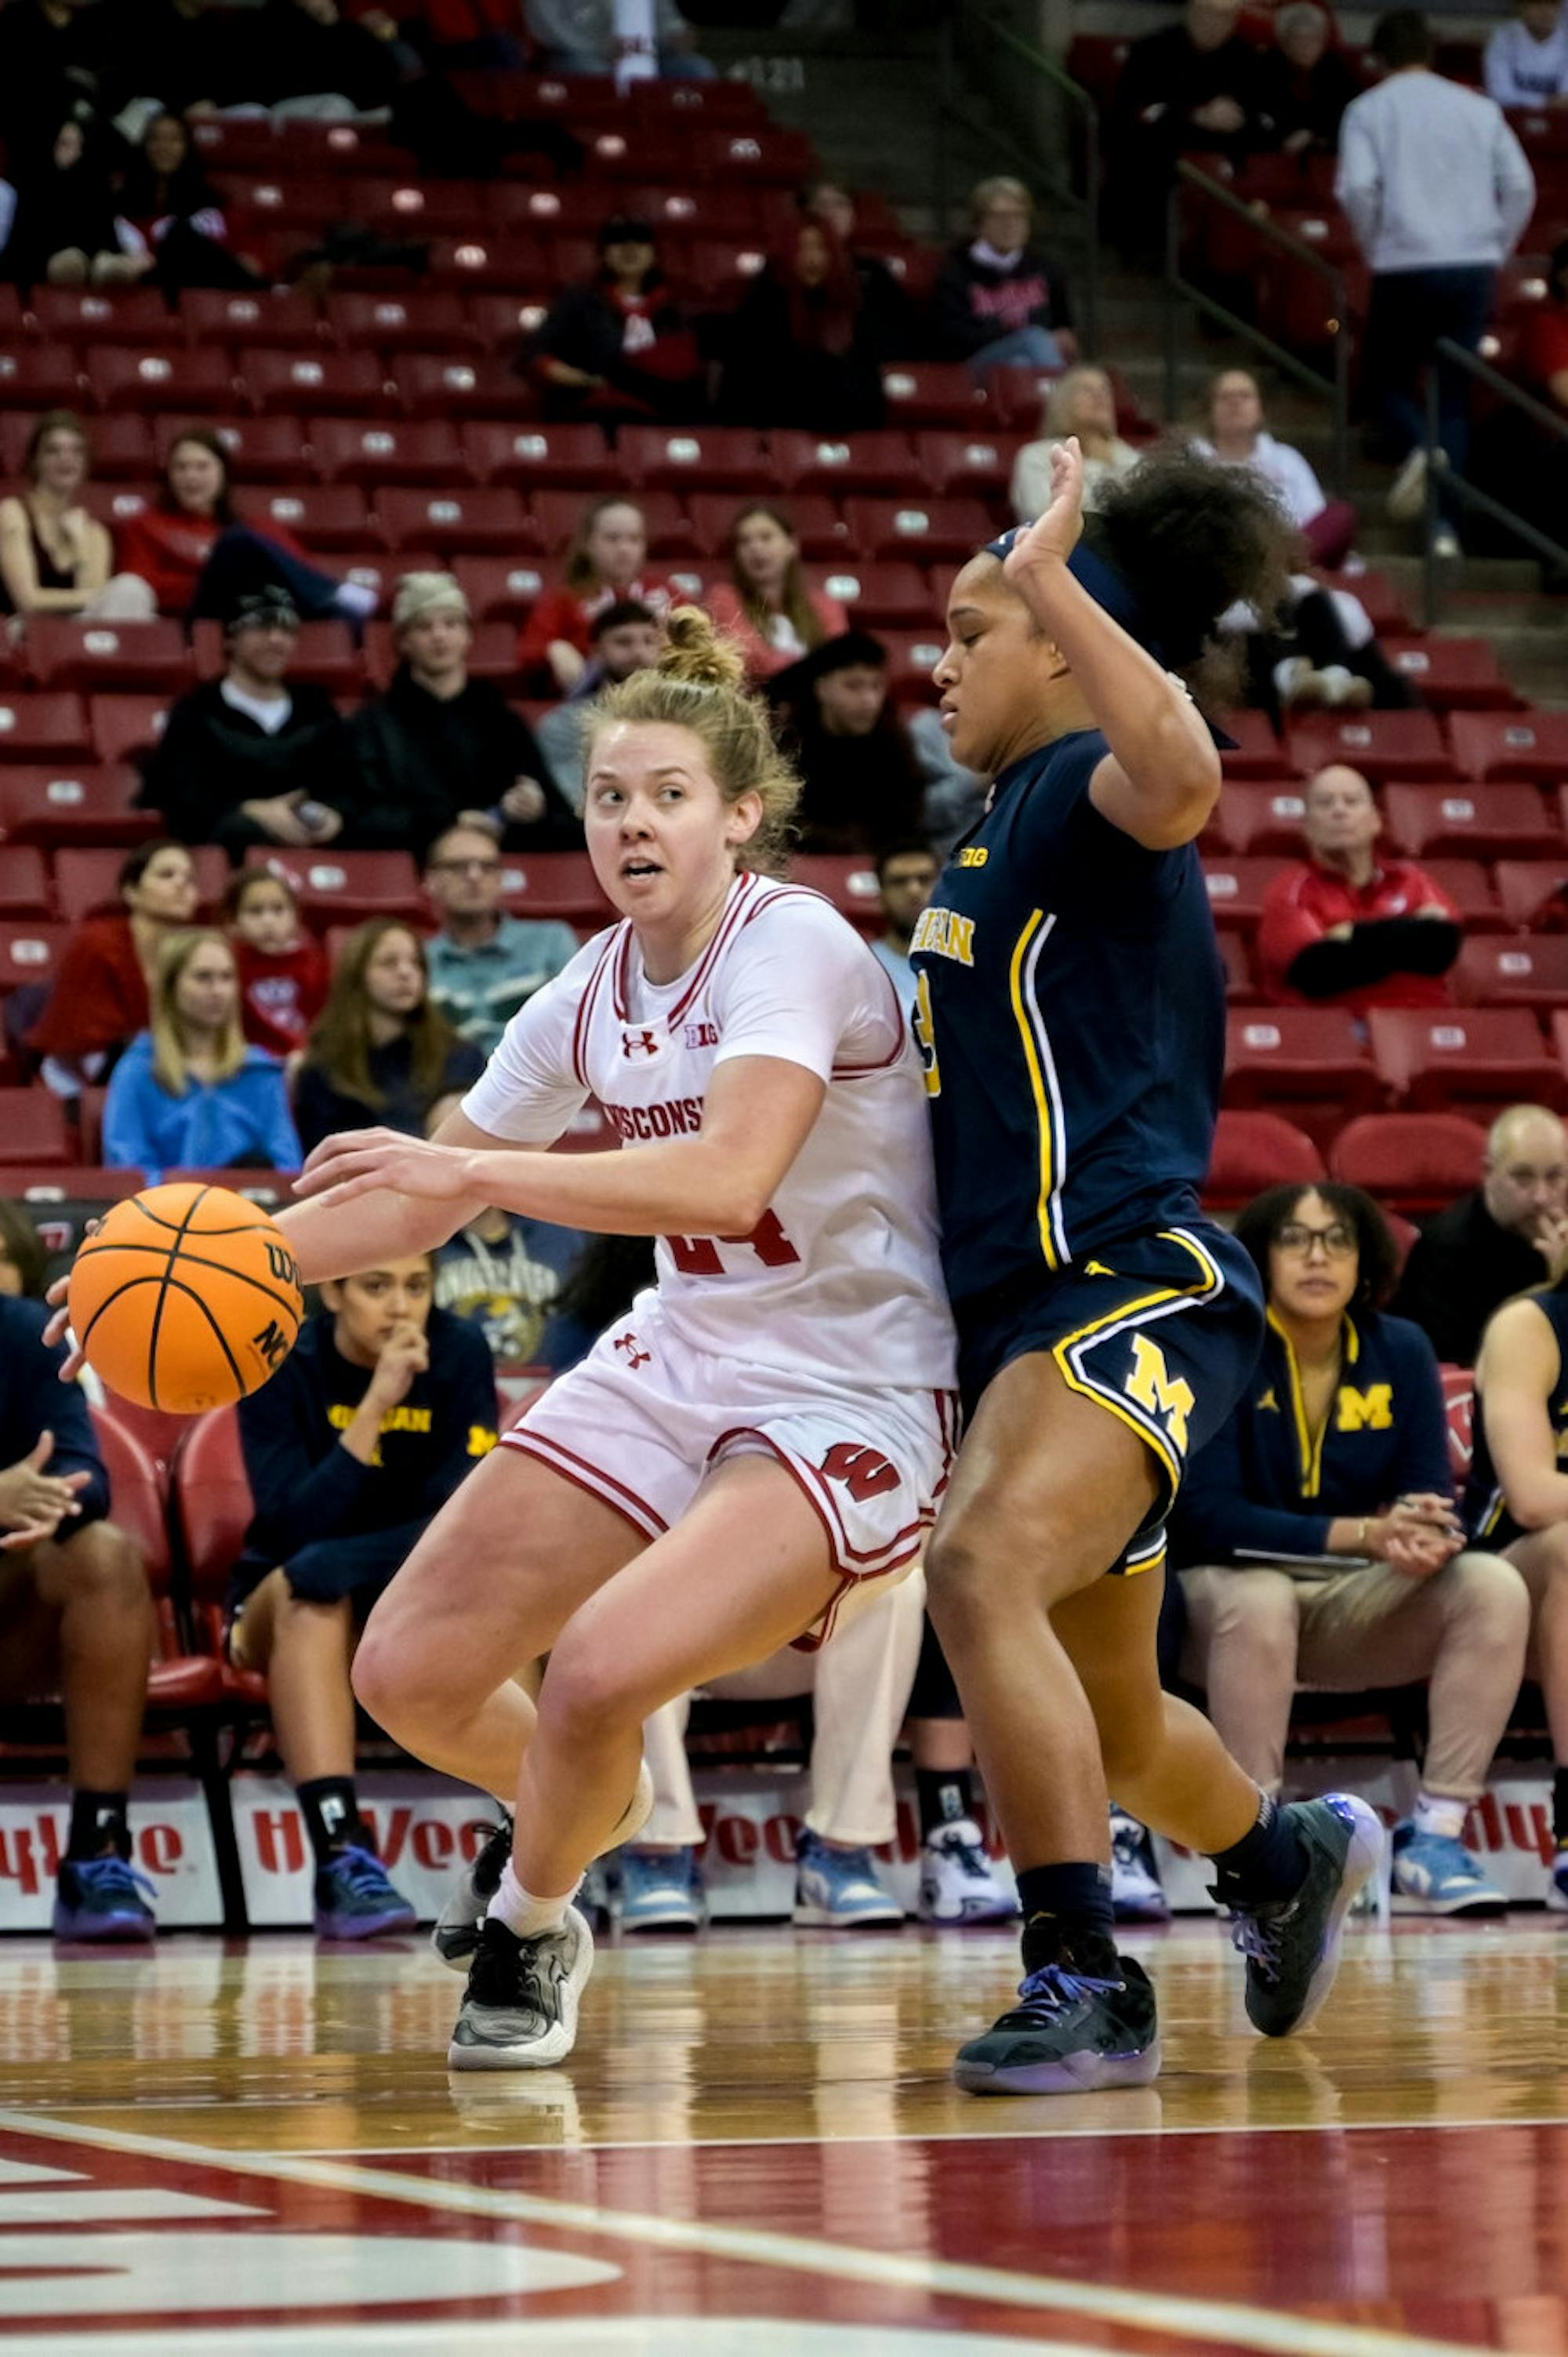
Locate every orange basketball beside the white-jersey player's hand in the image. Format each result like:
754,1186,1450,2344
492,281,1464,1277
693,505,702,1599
68,1183,304,1417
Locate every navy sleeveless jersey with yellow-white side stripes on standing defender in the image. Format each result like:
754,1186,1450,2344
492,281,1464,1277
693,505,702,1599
910,731,1224,1303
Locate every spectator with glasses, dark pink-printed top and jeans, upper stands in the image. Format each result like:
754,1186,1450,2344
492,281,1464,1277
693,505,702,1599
931,176,1077,384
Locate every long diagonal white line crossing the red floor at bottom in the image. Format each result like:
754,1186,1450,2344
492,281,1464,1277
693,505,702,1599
0,2112,1481,2357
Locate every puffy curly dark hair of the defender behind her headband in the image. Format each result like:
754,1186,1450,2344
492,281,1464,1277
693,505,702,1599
1084,450,1297,703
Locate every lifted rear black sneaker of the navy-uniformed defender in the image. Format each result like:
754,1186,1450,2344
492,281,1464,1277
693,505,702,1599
1210,1792,1381,2039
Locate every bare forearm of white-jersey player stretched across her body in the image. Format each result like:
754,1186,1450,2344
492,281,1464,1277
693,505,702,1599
288,1056,826,1268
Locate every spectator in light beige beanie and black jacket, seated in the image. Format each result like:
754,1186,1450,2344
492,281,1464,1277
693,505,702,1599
332,572,583,858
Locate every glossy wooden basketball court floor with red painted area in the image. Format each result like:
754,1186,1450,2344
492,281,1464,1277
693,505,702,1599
0,1912,1568,2357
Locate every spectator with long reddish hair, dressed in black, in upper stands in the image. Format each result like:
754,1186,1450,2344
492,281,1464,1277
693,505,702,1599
719,217,887,434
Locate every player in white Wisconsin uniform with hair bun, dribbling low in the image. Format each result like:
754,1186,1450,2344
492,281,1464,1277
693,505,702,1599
283,608,955,2069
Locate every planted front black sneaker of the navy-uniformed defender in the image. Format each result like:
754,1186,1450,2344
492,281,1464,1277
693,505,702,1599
953,1956,1160,2095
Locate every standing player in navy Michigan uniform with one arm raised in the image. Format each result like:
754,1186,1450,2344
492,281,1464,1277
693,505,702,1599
913,441,1381,2095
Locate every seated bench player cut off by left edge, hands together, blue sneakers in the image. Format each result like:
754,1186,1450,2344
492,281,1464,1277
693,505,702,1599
0,1287,155,1942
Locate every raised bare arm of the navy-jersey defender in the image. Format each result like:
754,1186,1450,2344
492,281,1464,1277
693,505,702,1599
1002,436,1219,851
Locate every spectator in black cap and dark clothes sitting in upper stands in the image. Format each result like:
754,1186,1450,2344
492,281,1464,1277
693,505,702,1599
524,212,707,424
